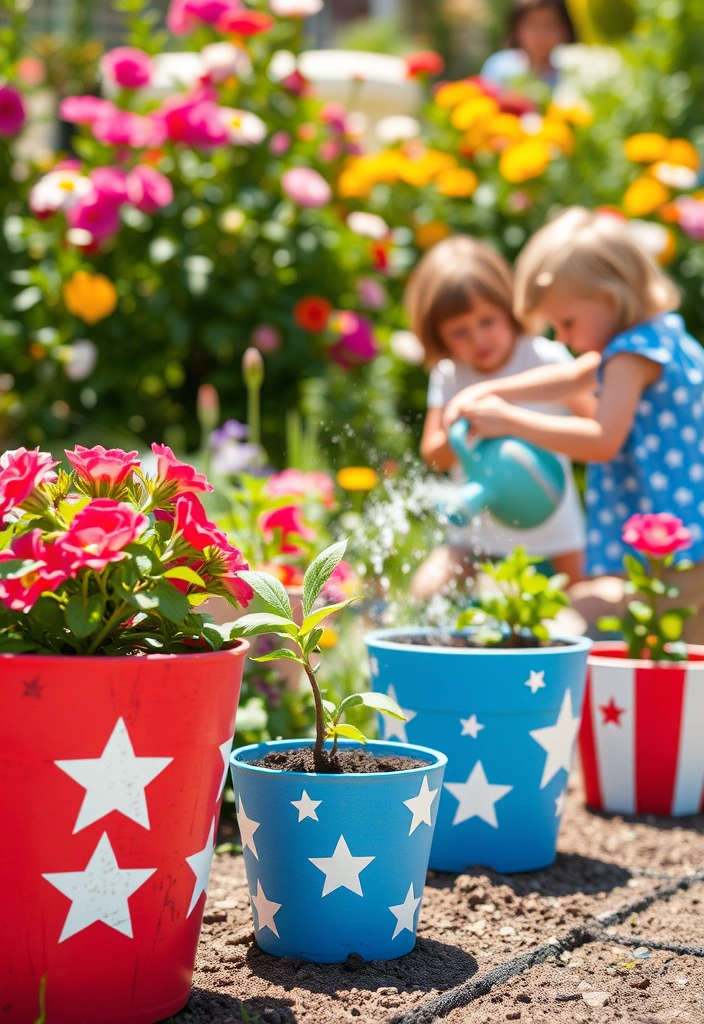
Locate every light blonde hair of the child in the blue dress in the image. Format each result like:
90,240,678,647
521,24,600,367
514,206,679,331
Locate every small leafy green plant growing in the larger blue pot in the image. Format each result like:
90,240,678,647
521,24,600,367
457,547,570,646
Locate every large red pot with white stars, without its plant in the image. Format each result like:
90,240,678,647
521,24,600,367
0,642,248,1024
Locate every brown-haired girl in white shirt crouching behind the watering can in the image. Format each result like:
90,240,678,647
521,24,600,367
406,234,596,600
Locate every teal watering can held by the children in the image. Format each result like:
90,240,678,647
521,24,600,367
441,419,565,529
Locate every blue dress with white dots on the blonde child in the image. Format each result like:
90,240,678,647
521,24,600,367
586,313,704,575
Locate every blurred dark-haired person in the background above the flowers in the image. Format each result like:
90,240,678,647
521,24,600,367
481,0,577,88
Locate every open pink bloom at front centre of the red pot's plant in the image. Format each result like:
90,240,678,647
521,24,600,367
56,498,149,574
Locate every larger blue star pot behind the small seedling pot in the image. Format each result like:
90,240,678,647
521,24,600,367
366,629,591,872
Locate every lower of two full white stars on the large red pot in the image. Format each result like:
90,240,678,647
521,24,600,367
42,833,157,942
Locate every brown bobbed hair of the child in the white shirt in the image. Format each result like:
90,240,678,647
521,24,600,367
405,234,520,366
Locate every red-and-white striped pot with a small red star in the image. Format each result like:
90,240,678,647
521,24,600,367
579,643,704,815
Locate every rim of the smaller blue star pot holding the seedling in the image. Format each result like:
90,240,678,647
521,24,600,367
230,739,447,785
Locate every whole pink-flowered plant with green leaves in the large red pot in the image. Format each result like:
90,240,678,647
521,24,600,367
0,444,253,654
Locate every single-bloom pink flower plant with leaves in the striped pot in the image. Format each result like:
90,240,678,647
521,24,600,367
599,512,697,662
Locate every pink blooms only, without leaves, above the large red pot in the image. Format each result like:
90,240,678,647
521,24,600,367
0,444,253,611
